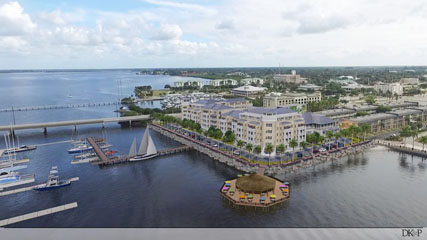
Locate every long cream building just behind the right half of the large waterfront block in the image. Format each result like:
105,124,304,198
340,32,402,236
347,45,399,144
263,92,322,107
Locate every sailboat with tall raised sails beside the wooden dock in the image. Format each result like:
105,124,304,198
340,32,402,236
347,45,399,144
128,127,157,161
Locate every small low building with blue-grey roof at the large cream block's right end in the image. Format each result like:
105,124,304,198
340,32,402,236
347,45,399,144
302,112,339,136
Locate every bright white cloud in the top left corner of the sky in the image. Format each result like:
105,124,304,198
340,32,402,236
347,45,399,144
0,2,36,36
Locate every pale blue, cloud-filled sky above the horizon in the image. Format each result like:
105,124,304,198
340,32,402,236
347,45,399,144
0,0,427,69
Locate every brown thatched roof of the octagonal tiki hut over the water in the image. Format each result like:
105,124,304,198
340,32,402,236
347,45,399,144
236,173,276,193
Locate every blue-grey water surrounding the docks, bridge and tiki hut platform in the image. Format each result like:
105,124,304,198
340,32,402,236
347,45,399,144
0,70,427,227
